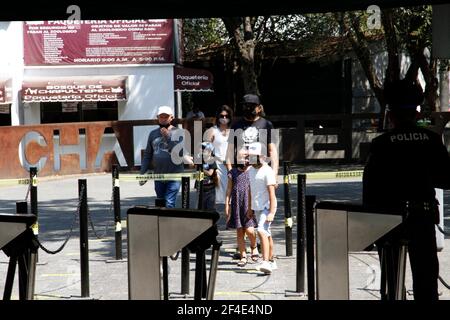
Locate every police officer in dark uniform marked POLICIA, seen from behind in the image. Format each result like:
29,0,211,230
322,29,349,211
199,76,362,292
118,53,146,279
363,79,450,300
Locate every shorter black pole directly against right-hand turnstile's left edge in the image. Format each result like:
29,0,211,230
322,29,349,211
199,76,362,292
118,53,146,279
305,196,316,300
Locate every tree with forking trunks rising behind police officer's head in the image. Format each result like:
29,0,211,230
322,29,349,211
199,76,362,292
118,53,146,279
335,6,438,126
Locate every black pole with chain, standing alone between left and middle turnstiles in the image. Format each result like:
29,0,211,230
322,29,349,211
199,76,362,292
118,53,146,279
78,179,89,298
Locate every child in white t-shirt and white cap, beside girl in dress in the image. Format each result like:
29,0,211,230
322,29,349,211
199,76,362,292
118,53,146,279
248,142,277,274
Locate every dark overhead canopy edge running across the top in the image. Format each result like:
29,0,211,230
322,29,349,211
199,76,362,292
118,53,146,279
0,0,449,21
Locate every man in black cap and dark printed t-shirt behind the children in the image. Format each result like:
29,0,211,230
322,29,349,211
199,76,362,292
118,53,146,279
226,94,279,180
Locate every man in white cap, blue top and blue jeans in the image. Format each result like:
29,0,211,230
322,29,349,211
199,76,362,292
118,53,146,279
139,106,184,208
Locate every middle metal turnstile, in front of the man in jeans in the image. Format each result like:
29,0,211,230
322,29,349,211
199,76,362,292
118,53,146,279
127,206,220,300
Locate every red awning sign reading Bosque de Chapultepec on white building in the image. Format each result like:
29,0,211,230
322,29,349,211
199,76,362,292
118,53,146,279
22,77,126,102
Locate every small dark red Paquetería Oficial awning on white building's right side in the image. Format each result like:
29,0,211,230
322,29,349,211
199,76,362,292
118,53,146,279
174,67,213,91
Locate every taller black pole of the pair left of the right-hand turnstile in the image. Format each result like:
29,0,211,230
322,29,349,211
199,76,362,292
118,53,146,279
296,174,306,292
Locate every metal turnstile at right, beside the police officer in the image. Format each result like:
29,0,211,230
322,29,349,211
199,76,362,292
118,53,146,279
315,201,406,300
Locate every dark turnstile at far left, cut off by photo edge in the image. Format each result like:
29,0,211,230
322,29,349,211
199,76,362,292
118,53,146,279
0,213,38,300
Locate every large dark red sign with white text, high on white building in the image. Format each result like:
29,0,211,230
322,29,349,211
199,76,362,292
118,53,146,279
23,19,173,66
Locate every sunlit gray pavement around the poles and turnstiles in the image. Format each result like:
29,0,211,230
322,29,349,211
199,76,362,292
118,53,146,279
0,166,450,300
